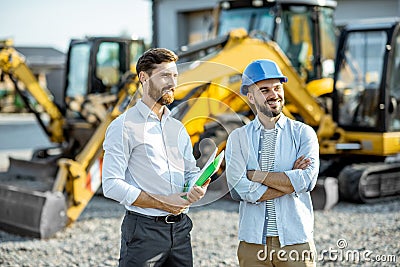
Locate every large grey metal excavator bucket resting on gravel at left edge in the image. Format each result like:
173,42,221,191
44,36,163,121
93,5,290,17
0,159,67,238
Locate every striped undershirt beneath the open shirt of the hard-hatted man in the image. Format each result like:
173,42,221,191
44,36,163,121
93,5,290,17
260,129,278,236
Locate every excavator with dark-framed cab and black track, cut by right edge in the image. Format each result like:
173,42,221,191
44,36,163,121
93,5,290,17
332,18,400,202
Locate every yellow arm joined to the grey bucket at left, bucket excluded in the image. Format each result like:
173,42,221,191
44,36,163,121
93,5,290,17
52,82,142,224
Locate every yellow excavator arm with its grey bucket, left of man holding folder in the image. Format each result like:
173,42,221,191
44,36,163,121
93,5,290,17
0,67,141,238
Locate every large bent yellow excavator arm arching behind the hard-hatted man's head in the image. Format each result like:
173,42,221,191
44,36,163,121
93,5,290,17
175,29,338,151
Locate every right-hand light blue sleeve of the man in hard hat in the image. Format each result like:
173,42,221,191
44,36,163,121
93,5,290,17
285,126,319,193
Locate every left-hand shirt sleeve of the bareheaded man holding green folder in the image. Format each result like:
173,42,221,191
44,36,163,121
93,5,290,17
102,115,141,206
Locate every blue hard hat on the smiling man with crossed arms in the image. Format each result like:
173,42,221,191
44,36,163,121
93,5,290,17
240,59,288,95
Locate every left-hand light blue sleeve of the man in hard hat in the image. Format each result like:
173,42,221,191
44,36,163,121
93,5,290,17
225,129,267,203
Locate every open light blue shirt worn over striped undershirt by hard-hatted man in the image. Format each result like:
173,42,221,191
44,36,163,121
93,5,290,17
226,114,319,247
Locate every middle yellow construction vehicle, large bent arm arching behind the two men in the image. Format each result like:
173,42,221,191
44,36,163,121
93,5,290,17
172,0,337,199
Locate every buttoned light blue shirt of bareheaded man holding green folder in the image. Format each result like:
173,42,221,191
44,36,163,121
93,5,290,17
102,100,199,216
